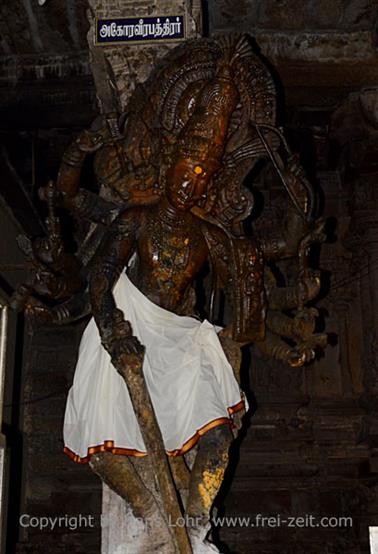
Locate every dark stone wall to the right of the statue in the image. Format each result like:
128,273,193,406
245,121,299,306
209,0,378,554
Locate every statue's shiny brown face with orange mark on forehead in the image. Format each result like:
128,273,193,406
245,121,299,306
166,158,216,211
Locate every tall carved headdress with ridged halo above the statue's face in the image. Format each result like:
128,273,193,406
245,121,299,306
96,35,276,226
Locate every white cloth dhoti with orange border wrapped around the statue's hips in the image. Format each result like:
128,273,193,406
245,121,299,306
64,273,244,463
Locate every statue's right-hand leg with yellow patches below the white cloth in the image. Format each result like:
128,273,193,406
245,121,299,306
186,425,233,552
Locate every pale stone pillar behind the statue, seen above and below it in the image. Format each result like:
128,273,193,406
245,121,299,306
83,0,202,554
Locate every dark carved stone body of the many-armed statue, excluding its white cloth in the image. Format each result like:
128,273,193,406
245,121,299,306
15,36,326,553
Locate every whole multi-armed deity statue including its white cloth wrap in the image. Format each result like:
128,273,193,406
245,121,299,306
15,36,326,554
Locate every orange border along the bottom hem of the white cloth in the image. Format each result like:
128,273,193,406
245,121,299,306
63,400,245,464
